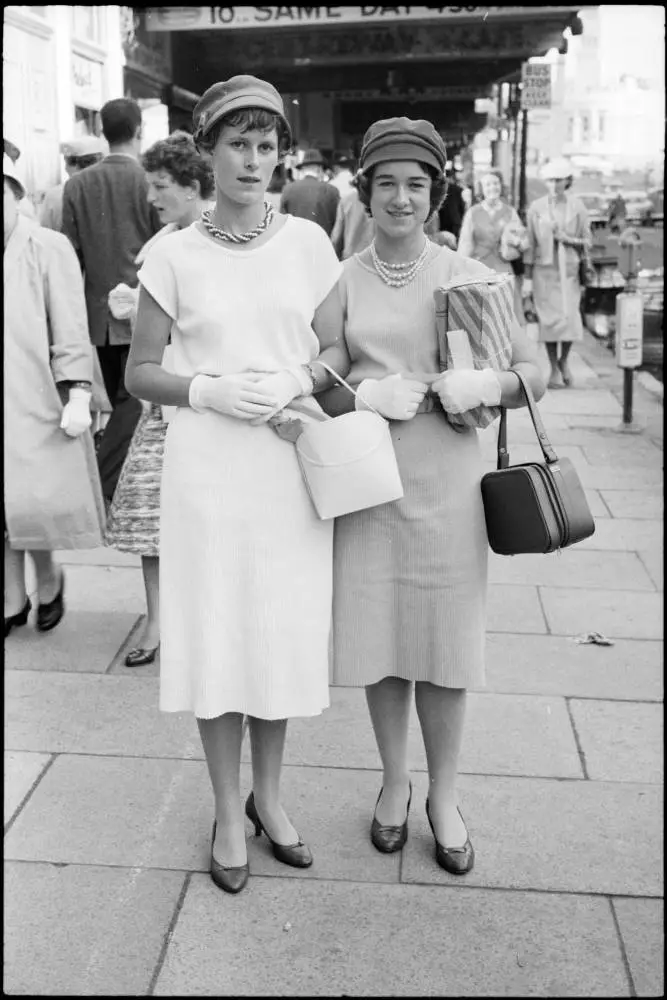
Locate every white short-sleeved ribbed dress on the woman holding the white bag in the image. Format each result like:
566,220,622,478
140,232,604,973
139,216,341,719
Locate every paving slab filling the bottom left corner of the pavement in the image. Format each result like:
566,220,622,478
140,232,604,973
3,862,184,997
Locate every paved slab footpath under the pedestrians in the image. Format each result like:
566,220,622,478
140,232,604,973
4,337,664,997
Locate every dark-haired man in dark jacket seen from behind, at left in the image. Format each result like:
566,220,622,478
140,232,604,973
62,98,161,503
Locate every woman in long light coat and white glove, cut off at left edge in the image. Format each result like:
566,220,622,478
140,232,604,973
3,156,104,636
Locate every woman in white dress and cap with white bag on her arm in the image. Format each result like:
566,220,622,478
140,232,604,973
127,76,347,892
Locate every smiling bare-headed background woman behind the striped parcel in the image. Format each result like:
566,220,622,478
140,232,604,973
458,170,528,326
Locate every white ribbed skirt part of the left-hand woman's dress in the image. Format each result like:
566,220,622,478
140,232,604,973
160,408,333,719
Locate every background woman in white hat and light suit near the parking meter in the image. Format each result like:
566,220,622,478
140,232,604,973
523,157,593,389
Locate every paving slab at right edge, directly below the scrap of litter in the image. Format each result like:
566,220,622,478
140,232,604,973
482,627,664,701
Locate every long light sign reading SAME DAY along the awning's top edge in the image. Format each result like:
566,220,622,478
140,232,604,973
146,5,581,31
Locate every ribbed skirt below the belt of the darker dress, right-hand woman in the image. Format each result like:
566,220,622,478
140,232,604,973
333,411,488,688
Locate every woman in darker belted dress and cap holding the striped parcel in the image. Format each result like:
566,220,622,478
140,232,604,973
321,118,544,874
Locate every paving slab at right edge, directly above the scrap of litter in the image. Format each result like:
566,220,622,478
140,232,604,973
540,587,664,639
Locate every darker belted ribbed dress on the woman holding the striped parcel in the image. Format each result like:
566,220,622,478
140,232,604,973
333,247,489,688
